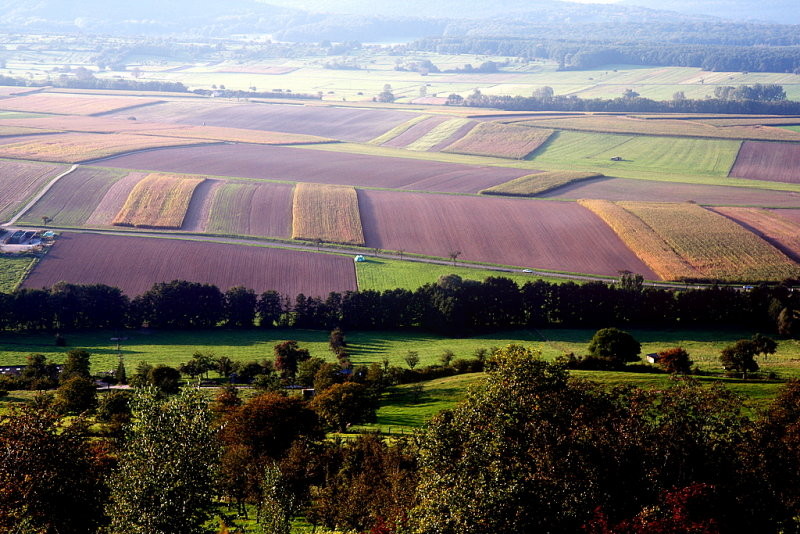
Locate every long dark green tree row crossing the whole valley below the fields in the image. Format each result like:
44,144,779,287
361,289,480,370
0,275,800,336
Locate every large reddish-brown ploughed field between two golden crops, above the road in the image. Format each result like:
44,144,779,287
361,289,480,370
358,190,656,279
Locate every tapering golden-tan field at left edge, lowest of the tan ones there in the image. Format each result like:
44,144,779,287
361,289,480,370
0,133,214,163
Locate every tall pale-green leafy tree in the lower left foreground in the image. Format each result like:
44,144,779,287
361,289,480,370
107,388,220,534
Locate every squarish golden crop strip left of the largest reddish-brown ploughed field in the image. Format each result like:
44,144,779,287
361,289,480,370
292,183,364,245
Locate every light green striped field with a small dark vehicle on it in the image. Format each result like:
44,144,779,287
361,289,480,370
531,132,740,177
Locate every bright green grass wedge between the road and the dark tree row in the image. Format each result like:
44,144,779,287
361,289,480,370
356,258,564,291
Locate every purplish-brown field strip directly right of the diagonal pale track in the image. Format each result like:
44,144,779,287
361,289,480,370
21,167,128,226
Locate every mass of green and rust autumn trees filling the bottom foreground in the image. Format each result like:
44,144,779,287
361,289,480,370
0,345,800,534
